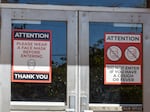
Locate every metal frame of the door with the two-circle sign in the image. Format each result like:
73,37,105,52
79,8,150,112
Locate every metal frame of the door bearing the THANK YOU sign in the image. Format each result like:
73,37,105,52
0,4,78,112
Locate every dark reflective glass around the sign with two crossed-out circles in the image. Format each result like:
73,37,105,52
89,22,143,104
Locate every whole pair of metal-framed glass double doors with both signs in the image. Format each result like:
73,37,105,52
0,5,150,112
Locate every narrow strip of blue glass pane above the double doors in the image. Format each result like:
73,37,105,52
2,0,146,7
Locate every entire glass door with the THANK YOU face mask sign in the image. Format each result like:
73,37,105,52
0,7,78,112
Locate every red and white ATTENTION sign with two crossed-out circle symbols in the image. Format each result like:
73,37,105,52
104,33,143,85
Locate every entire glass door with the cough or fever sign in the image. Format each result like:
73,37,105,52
79,8,149,112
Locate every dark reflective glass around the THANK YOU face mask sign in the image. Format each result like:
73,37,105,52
11,20,67,102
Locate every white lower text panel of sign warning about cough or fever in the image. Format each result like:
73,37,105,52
105,64,141,84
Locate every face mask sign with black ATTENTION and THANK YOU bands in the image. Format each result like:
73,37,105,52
12,29,52,83
